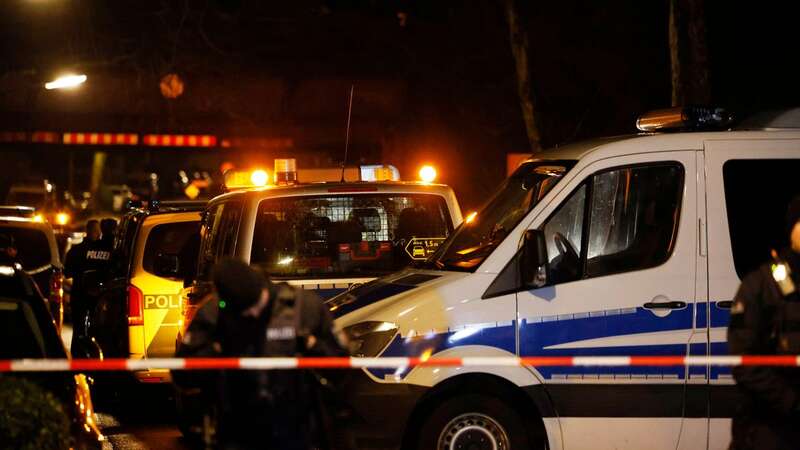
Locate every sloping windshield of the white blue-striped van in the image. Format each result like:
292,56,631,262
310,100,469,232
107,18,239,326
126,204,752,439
430,161,575,271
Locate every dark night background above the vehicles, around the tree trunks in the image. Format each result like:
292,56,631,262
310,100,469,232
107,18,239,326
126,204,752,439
0,0,800,208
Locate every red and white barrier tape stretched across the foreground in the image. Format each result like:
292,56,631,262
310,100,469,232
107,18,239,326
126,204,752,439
0,355,800,372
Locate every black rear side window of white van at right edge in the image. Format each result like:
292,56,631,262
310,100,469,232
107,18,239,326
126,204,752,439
722,159,800,279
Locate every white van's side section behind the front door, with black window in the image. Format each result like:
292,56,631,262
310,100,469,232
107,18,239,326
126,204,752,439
698,139,800,449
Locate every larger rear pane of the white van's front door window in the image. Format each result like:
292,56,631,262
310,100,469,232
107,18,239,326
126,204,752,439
586,164,683,277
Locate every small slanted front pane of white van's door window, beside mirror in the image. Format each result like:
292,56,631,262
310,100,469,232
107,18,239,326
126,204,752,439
544,184,586,284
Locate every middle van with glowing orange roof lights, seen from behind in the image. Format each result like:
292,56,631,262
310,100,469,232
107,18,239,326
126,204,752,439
173,159,462,435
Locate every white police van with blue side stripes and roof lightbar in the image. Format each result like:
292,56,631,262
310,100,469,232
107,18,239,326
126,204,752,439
329,108,800,450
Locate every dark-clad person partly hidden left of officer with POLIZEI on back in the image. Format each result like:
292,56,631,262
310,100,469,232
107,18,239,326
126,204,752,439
64,219,100,349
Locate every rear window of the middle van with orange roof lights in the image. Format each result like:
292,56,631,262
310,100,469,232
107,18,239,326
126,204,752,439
250,192,453,278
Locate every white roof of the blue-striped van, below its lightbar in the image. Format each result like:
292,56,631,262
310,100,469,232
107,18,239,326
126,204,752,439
530,129,800,161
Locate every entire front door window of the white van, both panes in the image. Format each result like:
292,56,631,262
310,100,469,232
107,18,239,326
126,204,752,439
542,163,684,284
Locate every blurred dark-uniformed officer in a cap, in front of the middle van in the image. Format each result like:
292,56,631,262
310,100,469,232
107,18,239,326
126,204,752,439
179,259,347,450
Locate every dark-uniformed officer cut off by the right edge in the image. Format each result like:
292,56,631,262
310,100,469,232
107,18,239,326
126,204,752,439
728,197,800,450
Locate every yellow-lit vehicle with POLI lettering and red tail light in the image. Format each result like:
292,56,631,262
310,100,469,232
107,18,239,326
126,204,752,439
92,201,205,383
